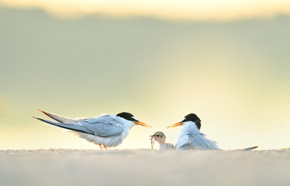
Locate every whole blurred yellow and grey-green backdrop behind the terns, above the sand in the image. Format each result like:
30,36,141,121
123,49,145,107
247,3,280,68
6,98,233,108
0,0,290,149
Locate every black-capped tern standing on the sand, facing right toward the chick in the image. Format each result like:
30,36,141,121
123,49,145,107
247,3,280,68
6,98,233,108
34,109,151,149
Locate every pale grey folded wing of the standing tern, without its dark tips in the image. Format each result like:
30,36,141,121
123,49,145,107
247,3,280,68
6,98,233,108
80,115,124,137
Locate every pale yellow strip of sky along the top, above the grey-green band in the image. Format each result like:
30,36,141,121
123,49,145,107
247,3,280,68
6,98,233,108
0,0,290,20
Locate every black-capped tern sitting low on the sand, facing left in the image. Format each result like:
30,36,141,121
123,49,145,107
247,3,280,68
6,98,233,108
168,113,258,151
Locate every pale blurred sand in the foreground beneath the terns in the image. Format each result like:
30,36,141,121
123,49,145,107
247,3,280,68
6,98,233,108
0,149,290,186
